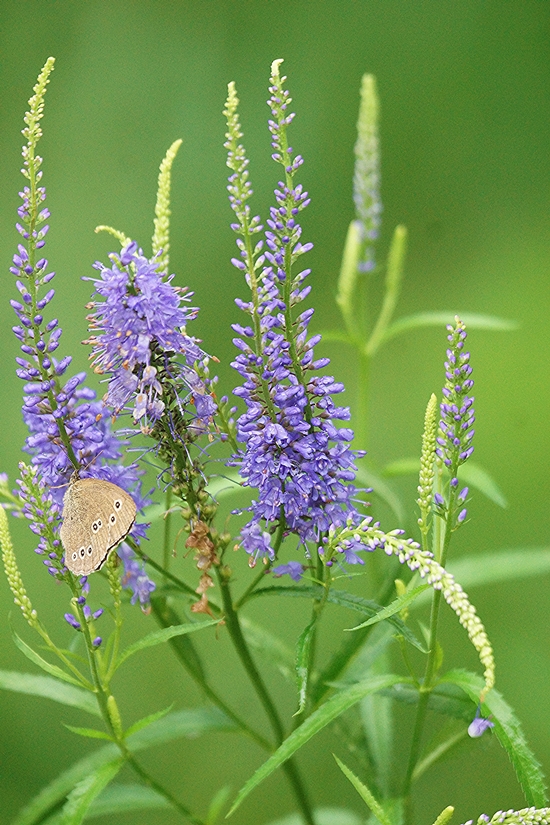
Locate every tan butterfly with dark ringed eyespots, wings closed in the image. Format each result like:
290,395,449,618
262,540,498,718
59,476,137,576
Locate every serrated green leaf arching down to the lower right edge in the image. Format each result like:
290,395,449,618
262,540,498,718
442,670,548,808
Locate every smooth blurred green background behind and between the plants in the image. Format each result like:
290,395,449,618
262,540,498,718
0,0,550,825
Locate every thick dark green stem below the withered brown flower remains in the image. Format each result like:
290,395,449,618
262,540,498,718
216,570,315,825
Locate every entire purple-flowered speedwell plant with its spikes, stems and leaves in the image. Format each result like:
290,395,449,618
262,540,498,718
0,54,544,825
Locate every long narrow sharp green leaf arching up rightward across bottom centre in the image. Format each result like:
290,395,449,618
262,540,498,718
227,674,403,816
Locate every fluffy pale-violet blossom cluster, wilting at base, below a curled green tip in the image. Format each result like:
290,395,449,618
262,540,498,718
88,241,216,435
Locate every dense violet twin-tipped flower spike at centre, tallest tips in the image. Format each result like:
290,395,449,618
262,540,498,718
228,61,365,574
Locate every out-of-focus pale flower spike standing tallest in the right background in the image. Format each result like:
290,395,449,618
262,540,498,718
353,74,382,272
